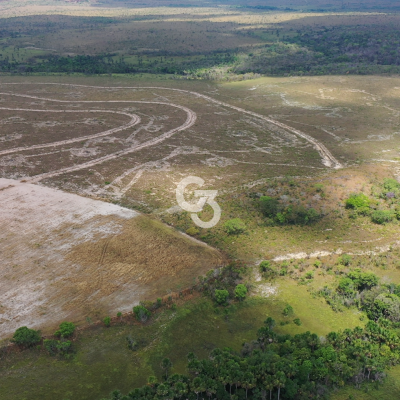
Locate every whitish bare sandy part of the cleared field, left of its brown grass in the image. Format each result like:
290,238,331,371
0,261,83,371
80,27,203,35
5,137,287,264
0,179,139,338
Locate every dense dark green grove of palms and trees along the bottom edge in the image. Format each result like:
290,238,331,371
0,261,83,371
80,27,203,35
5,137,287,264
101,318,400,400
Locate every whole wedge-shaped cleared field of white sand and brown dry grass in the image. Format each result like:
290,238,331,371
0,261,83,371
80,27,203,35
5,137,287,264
0,179,224,340
